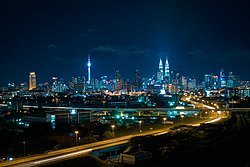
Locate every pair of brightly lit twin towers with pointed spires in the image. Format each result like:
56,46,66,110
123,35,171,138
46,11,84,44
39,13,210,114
157,58,170,82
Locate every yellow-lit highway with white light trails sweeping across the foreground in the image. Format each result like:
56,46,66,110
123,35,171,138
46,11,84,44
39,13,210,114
0,117,221,167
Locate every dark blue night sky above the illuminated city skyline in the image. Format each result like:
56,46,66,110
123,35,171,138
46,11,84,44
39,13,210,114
0,0,250,86
